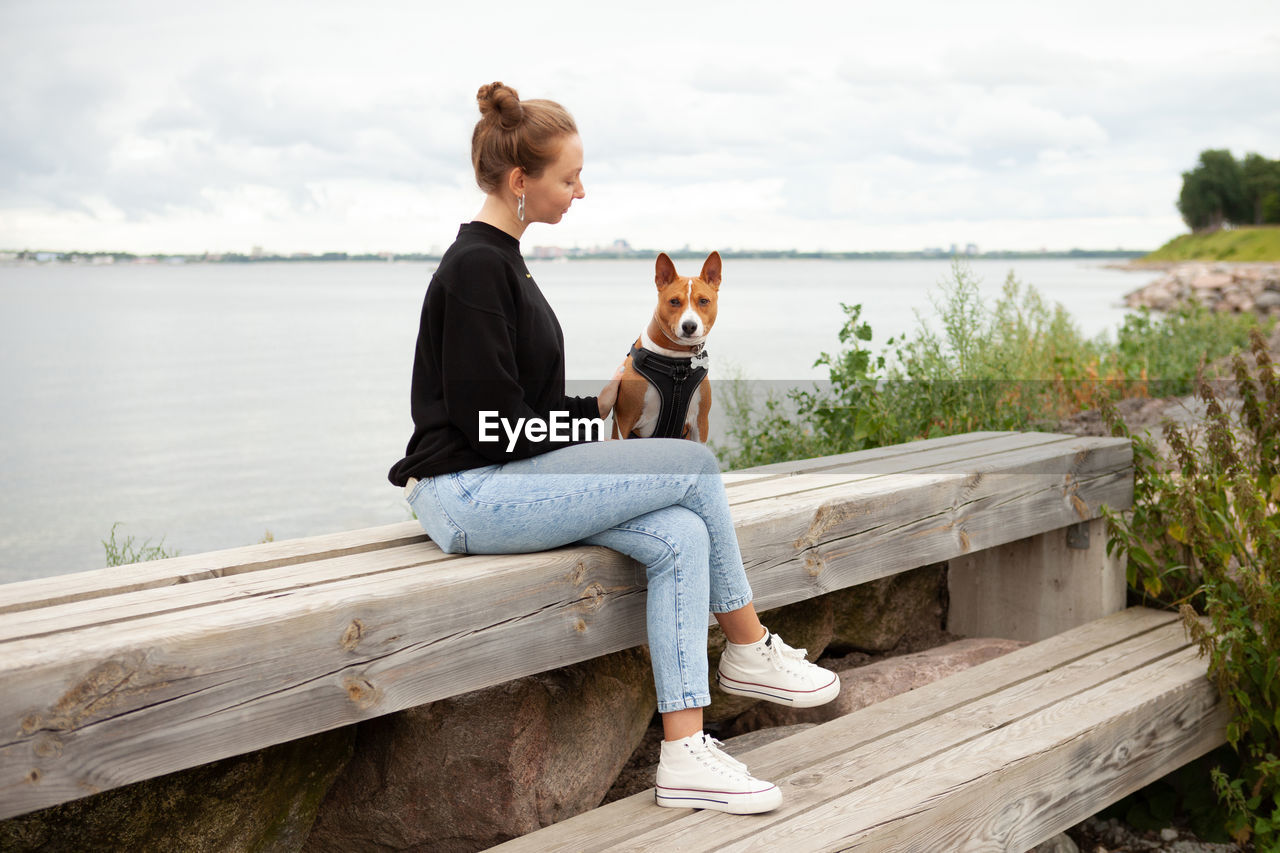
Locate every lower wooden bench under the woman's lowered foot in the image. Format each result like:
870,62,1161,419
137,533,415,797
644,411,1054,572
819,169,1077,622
492,607,1228,853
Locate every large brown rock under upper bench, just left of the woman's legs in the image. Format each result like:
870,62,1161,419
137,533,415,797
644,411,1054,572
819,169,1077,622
303,649,655,853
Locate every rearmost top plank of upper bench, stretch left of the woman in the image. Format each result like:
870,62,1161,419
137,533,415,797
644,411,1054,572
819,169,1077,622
0,521,428,613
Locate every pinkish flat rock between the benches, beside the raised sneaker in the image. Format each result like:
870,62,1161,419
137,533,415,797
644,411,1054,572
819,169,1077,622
726,639,1027,735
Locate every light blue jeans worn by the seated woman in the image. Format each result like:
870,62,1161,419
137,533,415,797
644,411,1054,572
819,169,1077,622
408,438,751,713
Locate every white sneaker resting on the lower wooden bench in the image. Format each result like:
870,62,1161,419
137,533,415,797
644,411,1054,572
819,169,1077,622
655,731,782,815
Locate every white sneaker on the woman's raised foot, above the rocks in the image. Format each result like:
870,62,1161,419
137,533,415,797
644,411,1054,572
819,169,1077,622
716,630,840,708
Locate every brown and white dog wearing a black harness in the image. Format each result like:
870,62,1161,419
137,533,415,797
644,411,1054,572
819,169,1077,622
613,252,721,442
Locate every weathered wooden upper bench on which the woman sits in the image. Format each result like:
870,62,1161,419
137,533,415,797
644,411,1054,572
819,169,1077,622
0,433,1133,817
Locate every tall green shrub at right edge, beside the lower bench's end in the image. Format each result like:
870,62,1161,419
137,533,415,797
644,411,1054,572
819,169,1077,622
1108,329,1280,850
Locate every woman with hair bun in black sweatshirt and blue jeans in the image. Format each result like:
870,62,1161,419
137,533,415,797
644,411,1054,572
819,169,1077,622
389,83,840,813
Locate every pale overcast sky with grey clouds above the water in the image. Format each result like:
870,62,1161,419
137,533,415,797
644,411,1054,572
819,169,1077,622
0,0,1280,252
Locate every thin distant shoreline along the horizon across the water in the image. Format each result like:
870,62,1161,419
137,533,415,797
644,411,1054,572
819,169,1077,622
0,248,1147,266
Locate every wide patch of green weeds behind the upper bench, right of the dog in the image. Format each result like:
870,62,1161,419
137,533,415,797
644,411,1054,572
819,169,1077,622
717,261,1258,467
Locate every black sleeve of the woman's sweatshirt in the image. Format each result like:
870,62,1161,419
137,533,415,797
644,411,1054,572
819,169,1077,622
436,252,599,464
